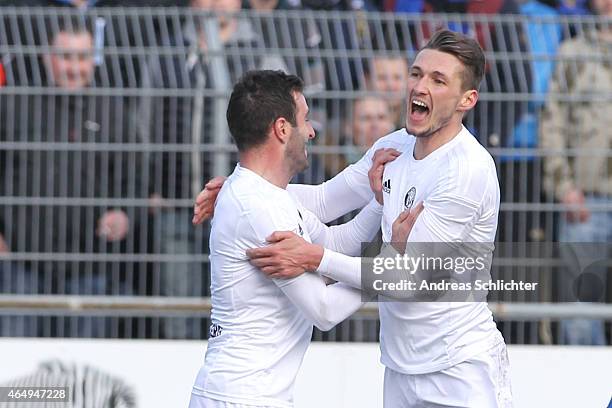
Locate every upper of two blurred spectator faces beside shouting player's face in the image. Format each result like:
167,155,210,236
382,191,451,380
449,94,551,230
366,56,408,128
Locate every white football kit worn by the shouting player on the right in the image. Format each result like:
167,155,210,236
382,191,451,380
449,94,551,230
290,128,510,408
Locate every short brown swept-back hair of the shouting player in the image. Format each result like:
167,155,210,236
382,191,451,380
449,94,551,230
421,30,485,90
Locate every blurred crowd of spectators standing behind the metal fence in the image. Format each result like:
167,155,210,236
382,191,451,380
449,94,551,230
0,0,612,344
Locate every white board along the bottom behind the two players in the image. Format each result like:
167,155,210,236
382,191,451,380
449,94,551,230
0,339,612,408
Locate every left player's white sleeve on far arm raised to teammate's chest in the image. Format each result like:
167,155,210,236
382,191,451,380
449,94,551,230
303,200,382,255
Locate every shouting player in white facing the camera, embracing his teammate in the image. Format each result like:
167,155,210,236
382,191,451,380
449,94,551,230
194,30,512,408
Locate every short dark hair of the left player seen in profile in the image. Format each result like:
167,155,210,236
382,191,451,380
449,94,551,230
227,70,304,151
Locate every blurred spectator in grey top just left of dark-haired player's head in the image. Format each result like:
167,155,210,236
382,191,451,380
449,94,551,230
140,0,287,338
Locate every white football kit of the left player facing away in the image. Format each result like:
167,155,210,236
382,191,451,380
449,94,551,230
190,165,382,408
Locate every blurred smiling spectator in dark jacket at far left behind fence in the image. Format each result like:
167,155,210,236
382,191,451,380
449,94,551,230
0,19,146,336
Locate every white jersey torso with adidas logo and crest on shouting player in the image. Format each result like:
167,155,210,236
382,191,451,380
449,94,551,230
379,128,500,374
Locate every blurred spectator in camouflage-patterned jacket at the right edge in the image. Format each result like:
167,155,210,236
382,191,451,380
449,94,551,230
540,0,612,344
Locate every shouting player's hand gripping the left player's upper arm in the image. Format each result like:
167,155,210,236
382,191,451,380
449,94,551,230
246,231,323,279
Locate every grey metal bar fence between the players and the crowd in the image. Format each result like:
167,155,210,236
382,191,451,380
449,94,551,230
0,8,612,344
